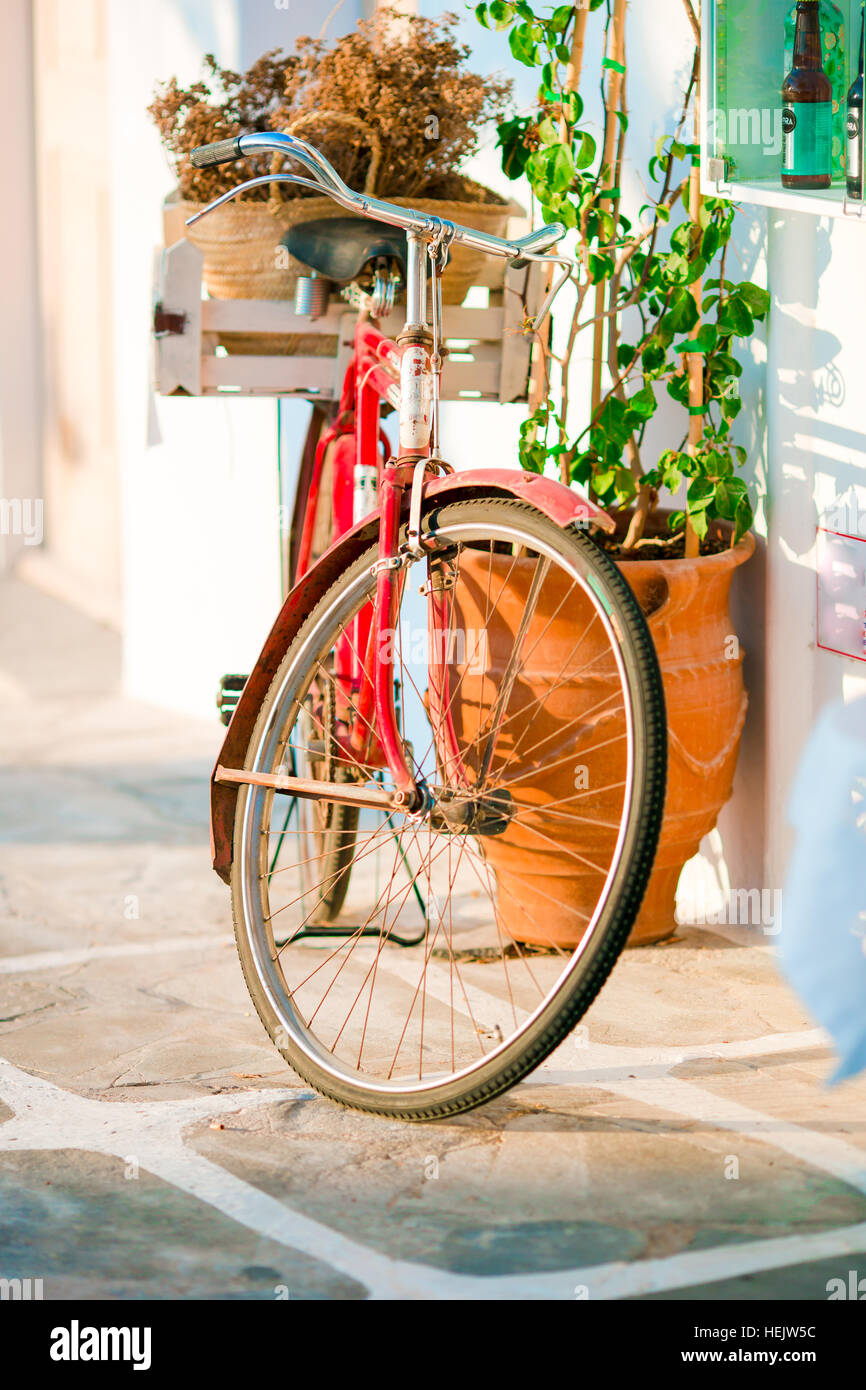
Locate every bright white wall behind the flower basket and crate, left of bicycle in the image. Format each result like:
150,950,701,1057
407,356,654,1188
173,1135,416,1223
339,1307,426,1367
110,0,359,716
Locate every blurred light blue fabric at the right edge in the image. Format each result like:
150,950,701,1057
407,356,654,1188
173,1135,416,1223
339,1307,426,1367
777,699,866,1081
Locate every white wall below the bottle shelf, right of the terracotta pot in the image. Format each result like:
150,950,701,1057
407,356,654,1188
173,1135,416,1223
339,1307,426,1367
767,213,866,885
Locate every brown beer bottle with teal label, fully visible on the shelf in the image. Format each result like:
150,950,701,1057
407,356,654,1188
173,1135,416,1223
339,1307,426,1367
781,0,833,189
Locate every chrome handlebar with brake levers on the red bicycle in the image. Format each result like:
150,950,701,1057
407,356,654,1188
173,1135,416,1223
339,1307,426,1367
186,131,573,331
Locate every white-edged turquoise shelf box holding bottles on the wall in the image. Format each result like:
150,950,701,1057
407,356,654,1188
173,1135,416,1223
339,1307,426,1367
701,0,866,224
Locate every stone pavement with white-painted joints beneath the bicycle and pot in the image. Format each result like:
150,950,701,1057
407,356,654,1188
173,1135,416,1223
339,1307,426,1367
0,581,866,1300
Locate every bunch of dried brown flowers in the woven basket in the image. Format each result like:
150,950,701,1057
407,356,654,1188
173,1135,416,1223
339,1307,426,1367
149,10,512,202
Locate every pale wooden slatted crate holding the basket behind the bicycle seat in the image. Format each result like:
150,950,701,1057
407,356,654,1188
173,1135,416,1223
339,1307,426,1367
153,238,544,402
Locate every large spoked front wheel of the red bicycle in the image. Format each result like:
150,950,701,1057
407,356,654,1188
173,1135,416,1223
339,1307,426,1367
232,496,666,1120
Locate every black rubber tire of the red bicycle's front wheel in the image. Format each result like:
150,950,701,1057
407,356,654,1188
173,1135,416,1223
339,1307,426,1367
226,495,667,1122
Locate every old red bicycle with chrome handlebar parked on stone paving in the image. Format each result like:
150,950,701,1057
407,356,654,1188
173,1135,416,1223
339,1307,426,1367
192,133,666,1120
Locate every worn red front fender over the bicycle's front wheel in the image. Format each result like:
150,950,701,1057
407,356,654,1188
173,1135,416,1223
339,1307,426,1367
210,468,614,883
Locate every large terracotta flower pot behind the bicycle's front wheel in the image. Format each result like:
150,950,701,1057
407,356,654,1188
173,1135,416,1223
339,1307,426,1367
457,518,755,945
